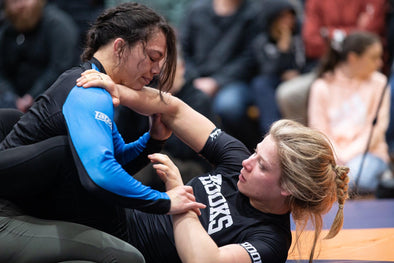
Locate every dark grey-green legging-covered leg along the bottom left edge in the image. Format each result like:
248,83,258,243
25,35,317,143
0,212,145,263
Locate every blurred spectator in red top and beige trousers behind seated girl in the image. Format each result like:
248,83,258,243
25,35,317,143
277,0,387,127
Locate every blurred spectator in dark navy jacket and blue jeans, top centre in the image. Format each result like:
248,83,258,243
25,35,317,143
180,0,261,150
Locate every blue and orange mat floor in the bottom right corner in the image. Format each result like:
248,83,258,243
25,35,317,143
288,198,394,263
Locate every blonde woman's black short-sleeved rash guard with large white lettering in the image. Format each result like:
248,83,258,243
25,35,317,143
127,130,291,263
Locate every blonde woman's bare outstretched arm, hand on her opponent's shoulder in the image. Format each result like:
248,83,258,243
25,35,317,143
77,70,215,152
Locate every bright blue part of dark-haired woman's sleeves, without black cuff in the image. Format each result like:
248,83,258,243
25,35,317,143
63,86,169,204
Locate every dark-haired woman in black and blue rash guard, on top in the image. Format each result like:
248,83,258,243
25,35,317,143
0,3,203,262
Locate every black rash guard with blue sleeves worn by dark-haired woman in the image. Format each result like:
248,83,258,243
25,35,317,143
0,58,170,238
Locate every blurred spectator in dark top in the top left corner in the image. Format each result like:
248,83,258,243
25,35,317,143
0,0,78,112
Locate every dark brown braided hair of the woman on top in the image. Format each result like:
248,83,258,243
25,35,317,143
81,2,177,90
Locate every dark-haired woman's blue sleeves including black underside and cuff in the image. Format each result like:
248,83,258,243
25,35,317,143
63,86,170,213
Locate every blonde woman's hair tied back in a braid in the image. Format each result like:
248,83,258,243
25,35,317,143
269,120,349,262
